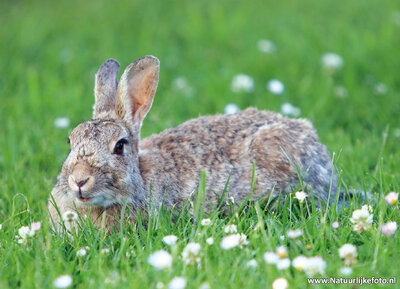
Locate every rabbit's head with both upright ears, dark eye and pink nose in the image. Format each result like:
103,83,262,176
52,56,159,208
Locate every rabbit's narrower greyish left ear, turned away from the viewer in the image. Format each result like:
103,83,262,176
93,59,119,119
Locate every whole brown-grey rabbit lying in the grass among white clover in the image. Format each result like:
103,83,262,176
48,56,337,230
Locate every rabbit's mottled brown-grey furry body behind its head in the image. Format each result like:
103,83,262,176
139,108,332,208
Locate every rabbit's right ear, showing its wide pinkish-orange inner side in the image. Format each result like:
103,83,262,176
115,55,160,129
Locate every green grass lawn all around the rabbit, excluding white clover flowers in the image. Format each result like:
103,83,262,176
0,0,400,289
